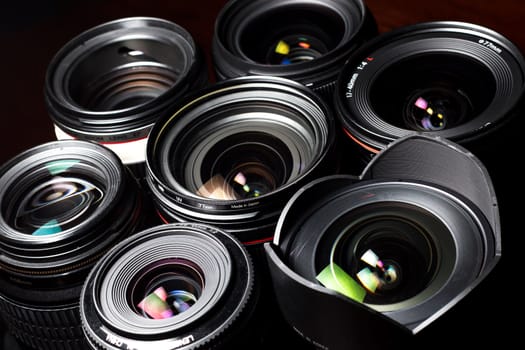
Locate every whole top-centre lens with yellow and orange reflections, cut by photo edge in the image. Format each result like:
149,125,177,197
212,0,377,103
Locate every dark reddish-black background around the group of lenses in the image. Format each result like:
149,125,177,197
0,0,525,350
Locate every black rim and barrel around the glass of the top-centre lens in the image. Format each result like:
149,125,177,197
212,0,377,94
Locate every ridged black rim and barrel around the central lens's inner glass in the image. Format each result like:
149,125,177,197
146,76,335,242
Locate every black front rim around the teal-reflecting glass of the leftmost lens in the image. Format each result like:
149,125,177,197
0,140,142,288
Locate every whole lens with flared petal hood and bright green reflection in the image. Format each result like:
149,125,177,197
264,134,501,349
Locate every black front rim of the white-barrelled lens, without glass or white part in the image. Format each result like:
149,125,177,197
45,17,207,143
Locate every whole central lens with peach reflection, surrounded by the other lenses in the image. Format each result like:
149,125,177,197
146,76,337,244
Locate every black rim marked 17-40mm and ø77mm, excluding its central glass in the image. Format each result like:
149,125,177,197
334,21,525,153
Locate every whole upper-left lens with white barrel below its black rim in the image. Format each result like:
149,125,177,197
44,17,208,176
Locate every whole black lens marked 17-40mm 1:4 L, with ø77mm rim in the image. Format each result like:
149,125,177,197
335,21,525,154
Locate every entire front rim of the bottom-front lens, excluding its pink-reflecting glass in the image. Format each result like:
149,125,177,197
80,223,256,348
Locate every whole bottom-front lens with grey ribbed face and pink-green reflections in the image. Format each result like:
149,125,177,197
80,223,257,349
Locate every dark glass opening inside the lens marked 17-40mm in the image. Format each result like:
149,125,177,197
369,53,496,131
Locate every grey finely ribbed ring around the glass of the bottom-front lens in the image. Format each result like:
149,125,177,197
94,228,232,335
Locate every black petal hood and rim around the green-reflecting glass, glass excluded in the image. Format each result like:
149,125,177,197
264,134,501,349
